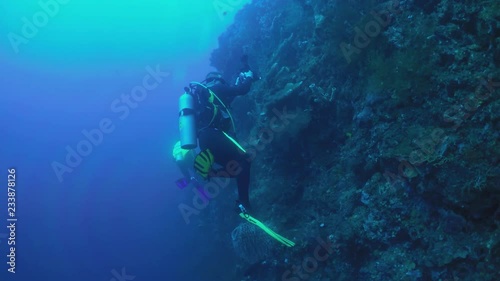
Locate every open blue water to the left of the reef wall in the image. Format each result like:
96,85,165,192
0,0,250,281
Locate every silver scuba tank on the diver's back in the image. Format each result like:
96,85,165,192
179,91,198,149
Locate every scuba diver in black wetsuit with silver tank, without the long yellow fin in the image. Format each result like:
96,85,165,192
179,65,253,209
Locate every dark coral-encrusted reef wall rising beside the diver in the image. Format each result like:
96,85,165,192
211,0,500,281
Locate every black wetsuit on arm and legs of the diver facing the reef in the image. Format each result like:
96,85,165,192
193,76,252,209
